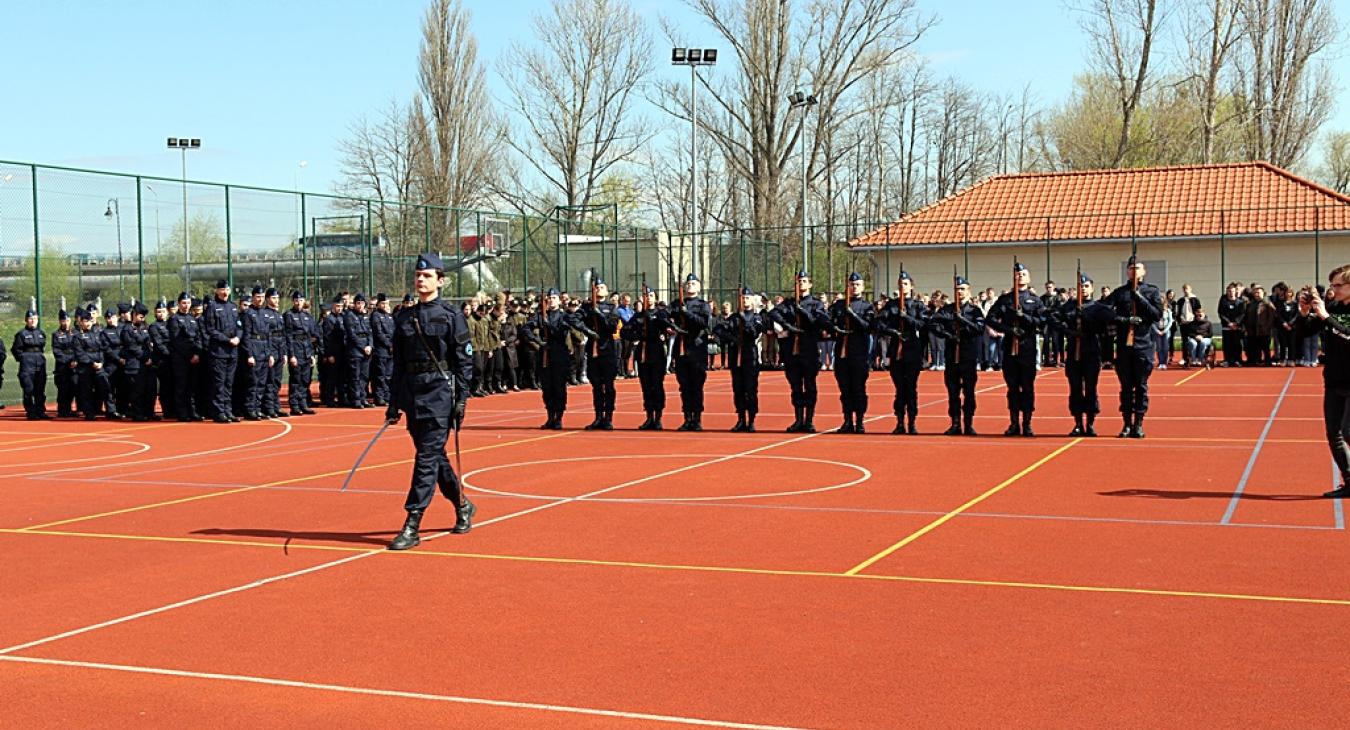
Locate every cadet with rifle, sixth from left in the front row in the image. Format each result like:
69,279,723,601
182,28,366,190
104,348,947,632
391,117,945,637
770,271,829,433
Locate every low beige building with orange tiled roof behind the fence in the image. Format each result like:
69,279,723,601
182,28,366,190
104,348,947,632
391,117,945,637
849,162,1350,300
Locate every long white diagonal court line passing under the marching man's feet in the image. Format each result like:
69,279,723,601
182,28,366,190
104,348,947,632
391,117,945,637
0,383,1004,657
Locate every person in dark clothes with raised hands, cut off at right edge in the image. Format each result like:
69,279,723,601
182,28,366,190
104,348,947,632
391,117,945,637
1295,264,1350,498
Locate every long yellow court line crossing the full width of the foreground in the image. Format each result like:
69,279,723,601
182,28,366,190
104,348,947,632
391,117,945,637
0,528,1350,606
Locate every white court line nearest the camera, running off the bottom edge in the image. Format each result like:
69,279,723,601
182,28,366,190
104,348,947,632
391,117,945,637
0,657,799,730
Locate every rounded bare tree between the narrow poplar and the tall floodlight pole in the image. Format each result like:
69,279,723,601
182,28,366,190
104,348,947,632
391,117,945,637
500,0,652,218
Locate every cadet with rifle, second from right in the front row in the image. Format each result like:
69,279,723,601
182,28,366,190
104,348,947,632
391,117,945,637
1053,274,1112,436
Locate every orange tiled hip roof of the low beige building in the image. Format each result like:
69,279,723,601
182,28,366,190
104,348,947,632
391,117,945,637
849,162,1350,246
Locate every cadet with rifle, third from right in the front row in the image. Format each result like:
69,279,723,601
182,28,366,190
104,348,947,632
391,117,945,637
987,263,1044,436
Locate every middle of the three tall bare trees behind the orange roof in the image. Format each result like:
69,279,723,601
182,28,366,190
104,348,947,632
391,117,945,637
1181,0,1243,163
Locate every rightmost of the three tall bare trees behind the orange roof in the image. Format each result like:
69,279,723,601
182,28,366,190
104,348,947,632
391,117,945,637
1238,0,1337,167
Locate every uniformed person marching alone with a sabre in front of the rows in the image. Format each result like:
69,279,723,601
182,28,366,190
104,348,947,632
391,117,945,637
385,254,475,551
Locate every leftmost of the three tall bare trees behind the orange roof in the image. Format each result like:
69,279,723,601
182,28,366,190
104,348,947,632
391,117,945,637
1081,0,1160,167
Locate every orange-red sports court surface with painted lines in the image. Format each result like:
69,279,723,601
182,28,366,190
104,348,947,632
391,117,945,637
0,368,1350,729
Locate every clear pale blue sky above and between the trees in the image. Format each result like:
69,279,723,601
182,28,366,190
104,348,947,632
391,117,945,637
0,0,1350,198
